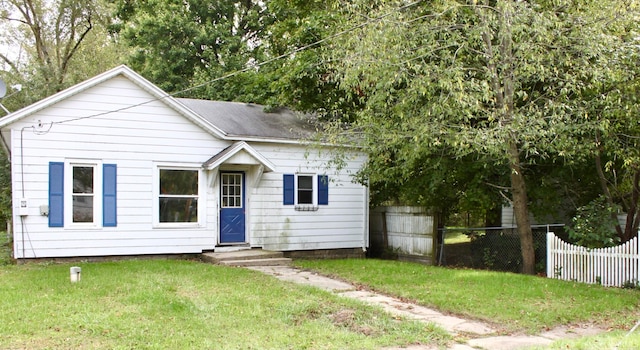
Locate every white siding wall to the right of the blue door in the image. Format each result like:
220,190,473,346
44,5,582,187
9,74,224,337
249,144,368,250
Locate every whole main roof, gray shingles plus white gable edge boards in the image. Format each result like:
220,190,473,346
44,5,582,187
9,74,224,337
0,65,315,143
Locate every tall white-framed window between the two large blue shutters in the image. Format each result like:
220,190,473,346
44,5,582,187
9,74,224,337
64,161,102,227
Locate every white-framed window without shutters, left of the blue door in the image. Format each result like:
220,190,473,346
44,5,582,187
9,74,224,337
154,165,205,227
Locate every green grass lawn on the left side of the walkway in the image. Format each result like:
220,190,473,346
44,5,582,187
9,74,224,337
0,260,449,349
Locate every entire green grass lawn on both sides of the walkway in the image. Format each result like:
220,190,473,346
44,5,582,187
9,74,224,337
0,227,640,349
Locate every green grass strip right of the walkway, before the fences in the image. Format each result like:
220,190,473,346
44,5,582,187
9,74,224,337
296,259,640,334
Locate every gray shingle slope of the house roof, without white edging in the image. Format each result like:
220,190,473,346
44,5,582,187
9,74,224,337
176,98,316,140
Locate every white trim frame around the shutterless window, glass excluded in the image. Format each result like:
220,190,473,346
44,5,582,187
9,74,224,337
152,163,206,228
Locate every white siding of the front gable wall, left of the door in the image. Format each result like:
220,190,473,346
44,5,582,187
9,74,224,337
7,77,220,258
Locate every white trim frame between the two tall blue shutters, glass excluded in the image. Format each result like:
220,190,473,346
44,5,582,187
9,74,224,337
63,159,104,229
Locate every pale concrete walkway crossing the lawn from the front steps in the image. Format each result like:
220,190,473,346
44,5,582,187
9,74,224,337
247,266,602,350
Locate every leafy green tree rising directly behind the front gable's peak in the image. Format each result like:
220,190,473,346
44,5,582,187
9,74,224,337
112,0,273,102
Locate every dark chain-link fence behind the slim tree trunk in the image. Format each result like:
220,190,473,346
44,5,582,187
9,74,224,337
438,224,564,273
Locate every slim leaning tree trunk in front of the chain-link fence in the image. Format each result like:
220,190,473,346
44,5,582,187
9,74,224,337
509,141,536,275
